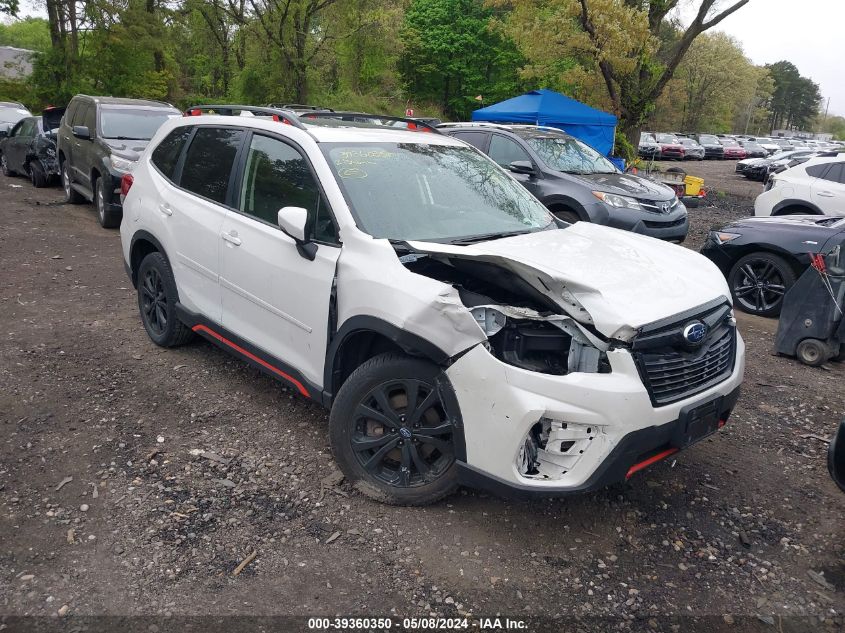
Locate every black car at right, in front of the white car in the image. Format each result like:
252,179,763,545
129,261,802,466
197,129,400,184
701,215,845,317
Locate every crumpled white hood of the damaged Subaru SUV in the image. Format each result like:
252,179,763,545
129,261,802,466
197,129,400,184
409,222,730,340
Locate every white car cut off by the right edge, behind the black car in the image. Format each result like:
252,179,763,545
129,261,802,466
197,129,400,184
754,153,845,215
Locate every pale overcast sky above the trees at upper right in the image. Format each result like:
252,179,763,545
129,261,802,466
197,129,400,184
681,0,845,116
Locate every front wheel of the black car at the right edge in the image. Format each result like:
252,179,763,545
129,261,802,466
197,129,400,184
728,253,795,317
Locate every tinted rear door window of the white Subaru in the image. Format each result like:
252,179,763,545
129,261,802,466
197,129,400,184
179,127,244,204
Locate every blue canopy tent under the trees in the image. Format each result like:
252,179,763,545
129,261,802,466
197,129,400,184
472,89,616,155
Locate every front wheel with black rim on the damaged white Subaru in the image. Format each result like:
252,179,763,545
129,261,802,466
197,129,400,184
329,353,460,506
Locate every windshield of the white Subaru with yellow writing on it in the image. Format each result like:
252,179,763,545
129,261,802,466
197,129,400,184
320,143,557,242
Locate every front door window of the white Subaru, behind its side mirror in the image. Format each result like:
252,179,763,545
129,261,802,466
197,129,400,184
238,134,336,242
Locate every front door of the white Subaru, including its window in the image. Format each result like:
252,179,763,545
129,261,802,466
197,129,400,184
220,133,340,385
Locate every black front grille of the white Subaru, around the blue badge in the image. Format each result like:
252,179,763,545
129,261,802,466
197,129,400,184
633,304,736,406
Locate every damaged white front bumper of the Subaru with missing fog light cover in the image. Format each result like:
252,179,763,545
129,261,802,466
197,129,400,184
446,333,745,497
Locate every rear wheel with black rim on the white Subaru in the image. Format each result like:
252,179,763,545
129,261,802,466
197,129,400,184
138,252,194,347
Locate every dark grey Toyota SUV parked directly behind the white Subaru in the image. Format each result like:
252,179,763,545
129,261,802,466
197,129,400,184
438,123,689,242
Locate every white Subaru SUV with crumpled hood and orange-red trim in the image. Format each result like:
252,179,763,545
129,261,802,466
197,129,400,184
120,106,744,504
